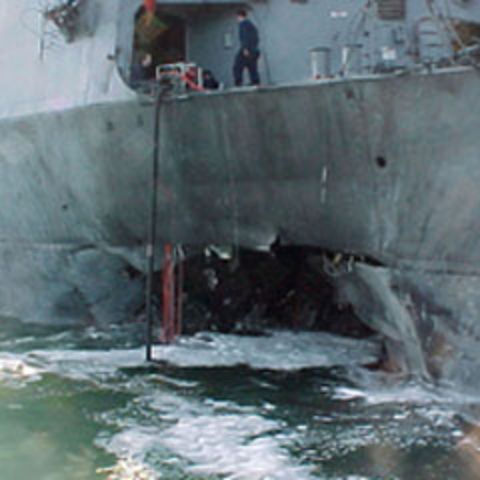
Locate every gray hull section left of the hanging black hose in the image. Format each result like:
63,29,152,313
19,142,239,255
0,103,152,324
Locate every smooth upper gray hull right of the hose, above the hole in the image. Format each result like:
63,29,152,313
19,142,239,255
158,66,480,273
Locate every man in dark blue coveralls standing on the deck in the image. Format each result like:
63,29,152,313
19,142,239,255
233,9,260,87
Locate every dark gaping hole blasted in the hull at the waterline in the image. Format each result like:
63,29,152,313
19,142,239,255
152,247,375,338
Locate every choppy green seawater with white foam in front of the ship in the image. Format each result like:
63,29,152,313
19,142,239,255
0,322,480,480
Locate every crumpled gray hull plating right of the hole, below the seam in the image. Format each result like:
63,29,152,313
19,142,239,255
335,265,480,393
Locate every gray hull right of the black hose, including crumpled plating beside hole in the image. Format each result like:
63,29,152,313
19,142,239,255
157,70,480,389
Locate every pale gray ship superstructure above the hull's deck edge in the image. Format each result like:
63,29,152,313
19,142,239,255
0,0,480,117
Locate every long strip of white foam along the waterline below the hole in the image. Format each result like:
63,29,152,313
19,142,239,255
0,331,378,381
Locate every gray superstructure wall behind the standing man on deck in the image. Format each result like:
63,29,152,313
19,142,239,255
117,0,480,87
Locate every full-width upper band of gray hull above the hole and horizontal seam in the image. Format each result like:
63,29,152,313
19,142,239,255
5,71,480,273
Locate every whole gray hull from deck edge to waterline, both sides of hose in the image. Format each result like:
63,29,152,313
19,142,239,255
0,70,480,386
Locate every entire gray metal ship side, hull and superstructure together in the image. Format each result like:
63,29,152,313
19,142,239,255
0,0,480,384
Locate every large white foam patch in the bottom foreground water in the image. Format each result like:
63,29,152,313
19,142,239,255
97,378,315,480
